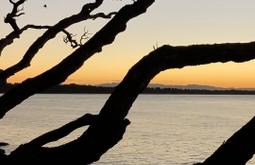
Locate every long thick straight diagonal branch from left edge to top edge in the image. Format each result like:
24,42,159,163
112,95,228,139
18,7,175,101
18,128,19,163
0,0,154,118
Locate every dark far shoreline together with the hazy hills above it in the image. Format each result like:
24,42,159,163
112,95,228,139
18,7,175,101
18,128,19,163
0,83,255,95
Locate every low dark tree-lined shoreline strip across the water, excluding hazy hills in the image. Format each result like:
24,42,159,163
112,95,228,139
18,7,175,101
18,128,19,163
0,84,255,95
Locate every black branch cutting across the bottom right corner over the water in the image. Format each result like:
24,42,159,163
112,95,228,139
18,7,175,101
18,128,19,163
200,117,255,165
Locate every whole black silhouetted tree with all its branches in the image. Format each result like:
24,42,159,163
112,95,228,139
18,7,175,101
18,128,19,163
0,0,255,165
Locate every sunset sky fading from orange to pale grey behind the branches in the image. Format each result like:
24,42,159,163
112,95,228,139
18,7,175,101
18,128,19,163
0,0,255,88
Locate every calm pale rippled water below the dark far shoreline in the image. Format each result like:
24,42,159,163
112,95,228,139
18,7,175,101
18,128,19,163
0,94,255,165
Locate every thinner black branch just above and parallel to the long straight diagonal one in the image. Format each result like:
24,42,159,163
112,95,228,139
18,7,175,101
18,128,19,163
0,0,103,82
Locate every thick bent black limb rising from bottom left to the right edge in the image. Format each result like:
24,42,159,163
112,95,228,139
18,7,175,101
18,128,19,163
6,42,255,165
